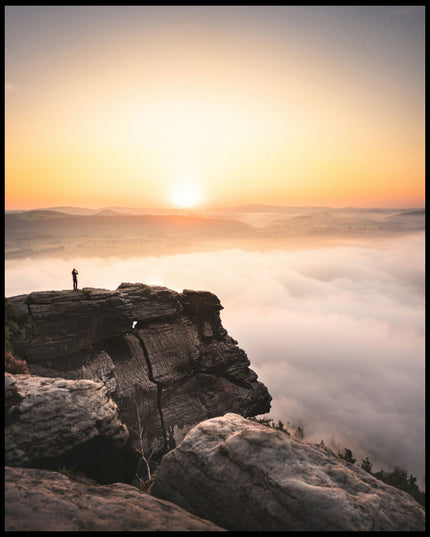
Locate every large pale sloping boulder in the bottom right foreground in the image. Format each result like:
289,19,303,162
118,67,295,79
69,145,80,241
152,414,425,531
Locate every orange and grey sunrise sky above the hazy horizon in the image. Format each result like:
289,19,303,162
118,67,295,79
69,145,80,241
5,6,425,209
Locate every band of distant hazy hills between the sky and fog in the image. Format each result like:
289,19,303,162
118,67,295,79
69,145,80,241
5,205,425,259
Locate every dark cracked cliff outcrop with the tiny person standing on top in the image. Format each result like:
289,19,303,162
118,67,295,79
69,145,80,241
8,284,271,455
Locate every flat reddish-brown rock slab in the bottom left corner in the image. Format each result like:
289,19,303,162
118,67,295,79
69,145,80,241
5,467,223,531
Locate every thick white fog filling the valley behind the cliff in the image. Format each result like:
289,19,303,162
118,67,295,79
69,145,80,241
5,232,425,487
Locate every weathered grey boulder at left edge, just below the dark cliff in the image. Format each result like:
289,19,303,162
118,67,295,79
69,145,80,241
5,373,136,481
